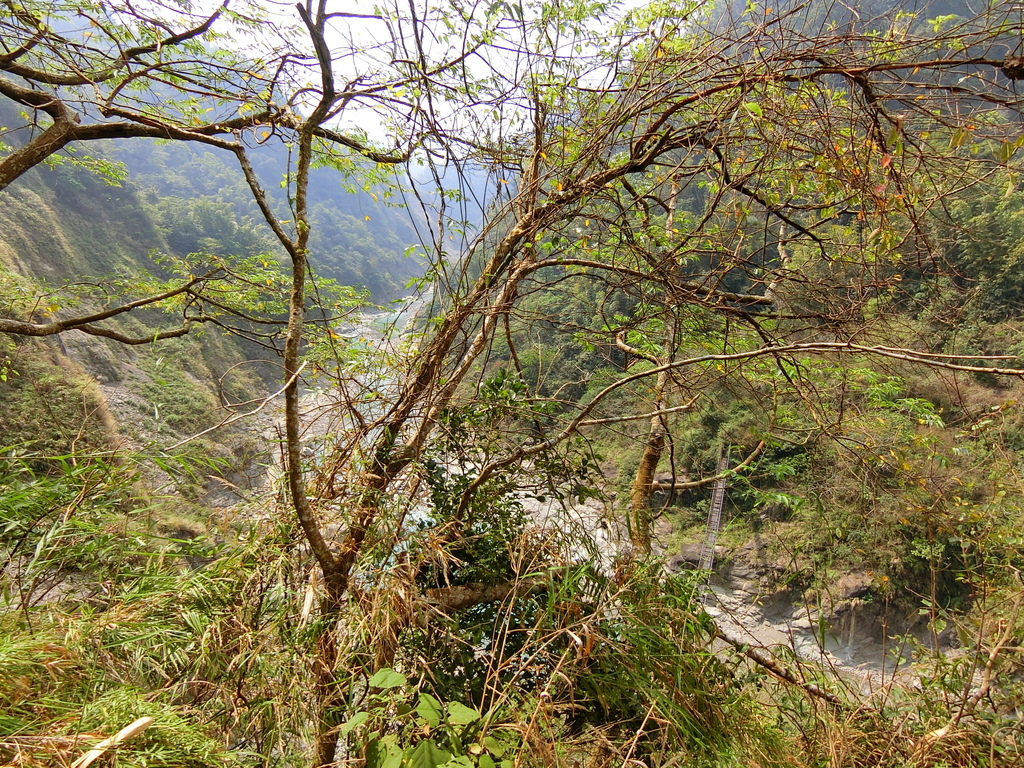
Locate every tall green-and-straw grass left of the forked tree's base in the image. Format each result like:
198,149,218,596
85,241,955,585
0,450,308,767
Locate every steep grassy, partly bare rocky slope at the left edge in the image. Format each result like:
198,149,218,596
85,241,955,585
0,146,272,498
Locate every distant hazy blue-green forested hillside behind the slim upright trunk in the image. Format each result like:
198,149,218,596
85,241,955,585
109,141,424,302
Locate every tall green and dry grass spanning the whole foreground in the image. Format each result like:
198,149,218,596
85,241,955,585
0,448,1024,768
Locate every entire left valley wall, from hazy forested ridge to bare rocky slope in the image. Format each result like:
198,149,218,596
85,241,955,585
0,115,421,503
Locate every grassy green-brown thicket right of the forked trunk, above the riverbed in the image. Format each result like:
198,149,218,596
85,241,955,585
387,545,786,768
